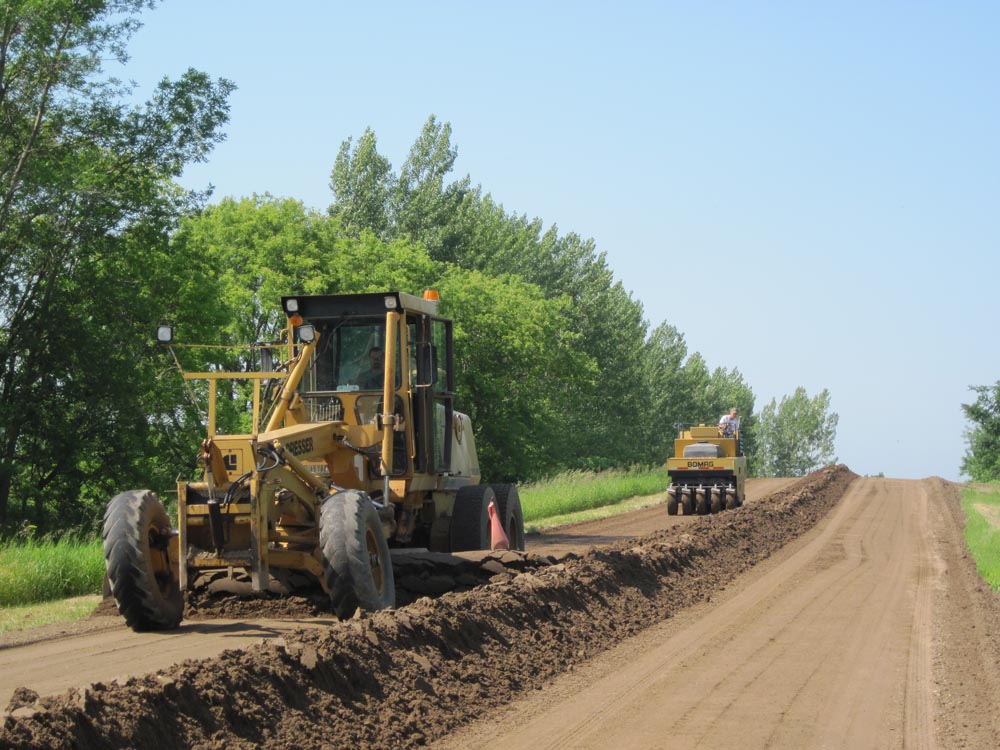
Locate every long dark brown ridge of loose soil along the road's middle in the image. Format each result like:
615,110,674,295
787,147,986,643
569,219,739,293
0,466,855,750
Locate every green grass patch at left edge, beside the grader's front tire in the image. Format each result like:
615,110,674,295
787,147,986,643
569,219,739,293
0,537,104,608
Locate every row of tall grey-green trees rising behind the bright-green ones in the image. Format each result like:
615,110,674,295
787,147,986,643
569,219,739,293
330,115,788,478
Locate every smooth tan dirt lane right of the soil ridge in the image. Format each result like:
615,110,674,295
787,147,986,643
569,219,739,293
440,479,996,750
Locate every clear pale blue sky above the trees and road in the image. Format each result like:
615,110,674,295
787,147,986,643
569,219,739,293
115,0,1000,479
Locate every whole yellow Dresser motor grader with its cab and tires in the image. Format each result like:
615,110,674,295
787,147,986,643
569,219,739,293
104,292,524,630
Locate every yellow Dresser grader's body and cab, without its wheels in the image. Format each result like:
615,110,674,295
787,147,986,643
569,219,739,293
177,293,492,590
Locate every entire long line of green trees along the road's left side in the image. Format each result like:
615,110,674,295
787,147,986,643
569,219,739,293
0,0,836,533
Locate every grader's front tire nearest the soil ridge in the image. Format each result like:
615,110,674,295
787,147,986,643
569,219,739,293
319,490,396,620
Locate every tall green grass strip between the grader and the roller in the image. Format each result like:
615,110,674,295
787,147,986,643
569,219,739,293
518,468,670,528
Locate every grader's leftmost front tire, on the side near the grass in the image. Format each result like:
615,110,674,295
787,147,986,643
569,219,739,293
102,490,184,630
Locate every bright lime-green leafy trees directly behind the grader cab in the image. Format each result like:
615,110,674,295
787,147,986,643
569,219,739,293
172,196,596,481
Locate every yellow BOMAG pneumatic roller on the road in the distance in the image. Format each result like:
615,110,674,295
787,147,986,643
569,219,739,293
667,424,747,516
